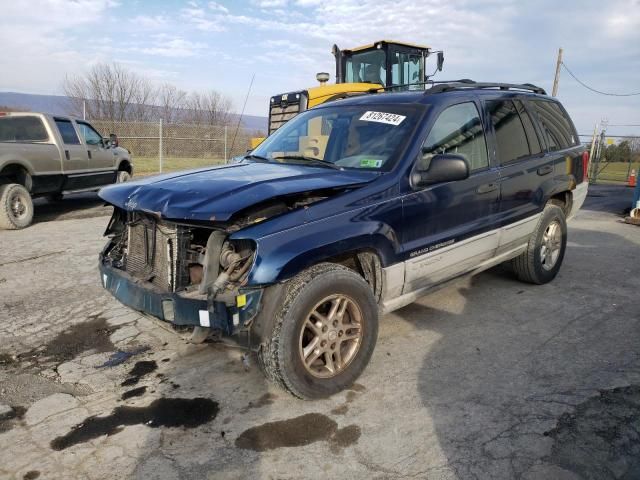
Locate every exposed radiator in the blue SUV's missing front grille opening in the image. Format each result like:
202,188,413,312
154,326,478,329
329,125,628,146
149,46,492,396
126,214,189,292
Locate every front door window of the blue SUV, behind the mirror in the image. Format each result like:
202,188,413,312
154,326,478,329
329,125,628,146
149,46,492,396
422,102,489,171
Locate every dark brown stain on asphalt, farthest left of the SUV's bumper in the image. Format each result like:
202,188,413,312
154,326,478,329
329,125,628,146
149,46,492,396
35,316,119,364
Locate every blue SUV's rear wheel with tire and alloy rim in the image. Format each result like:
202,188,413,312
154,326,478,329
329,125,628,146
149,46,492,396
511,203,567,285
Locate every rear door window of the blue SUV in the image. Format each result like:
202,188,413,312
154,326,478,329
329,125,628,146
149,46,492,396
487,100,531,165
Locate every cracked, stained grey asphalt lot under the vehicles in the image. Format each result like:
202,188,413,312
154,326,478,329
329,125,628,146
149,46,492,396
0,186,640,480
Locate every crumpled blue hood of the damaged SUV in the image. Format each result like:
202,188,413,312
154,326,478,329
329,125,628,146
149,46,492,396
98,163,379,221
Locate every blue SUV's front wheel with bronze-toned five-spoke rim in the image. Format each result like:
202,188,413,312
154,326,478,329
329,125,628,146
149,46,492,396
258,263,378,399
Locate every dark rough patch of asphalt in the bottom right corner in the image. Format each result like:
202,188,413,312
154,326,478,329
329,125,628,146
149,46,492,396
545,385,640,479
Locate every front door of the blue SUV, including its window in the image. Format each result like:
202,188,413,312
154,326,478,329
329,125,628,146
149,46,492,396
402,101,499,293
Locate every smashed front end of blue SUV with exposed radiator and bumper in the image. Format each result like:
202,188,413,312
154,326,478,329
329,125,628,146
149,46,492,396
99,208,262,342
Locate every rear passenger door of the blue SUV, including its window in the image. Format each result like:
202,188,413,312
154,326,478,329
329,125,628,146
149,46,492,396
485,98,554,253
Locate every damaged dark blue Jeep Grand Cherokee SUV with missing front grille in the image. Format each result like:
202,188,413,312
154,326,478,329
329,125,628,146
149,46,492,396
100,81,589,399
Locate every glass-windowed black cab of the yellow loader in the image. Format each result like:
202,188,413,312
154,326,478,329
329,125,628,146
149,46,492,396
332,40,432,90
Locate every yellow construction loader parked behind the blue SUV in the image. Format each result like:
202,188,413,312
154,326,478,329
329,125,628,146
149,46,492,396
251,40,444,148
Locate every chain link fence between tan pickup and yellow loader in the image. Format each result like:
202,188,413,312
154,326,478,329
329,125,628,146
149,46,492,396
91,120,264,175
